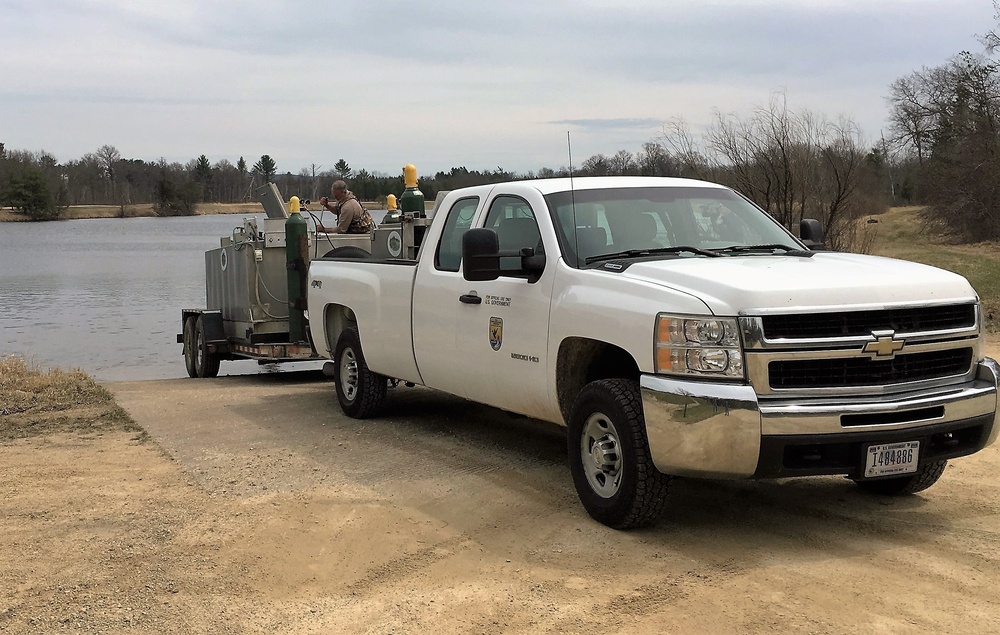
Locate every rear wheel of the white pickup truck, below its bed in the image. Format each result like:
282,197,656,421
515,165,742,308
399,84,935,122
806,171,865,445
333,326,387,419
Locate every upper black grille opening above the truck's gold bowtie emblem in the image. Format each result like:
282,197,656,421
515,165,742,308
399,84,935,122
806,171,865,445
761,304,976,340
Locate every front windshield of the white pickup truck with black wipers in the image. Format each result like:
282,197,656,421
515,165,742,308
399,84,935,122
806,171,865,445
545,187,803,267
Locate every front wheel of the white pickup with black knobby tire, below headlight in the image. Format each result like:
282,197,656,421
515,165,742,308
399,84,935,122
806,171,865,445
567,379,670,529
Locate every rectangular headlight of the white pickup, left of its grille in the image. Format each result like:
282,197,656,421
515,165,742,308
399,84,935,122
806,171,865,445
654,313,743,379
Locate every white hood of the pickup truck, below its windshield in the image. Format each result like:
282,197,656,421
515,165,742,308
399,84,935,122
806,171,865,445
618,252,977,315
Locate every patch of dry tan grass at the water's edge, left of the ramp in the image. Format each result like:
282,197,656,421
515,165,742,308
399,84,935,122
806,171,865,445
0,356,145,442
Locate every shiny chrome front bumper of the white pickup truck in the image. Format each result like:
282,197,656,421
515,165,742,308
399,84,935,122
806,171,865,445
639,357,1000,478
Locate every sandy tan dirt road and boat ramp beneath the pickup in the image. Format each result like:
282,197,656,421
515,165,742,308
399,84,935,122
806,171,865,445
0,358,1000,634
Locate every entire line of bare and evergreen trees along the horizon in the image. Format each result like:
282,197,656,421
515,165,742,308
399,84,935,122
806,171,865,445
0,6,1000,251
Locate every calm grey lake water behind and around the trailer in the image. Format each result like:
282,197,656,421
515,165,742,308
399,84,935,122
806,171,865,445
0,212,384,381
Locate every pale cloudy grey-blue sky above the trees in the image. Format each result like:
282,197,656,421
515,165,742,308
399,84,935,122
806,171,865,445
0,0,996,174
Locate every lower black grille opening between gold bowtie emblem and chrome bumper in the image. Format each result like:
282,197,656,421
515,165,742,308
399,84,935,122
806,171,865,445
768,348,972,389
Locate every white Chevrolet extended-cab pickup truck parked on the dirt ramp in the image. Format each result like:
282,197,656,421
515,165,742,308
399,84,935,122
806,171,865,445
308,177,1000,528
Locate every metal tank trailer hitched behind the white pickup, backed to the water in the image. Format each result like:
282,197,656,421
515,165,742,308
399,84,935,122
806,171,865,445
177,183,447,378
